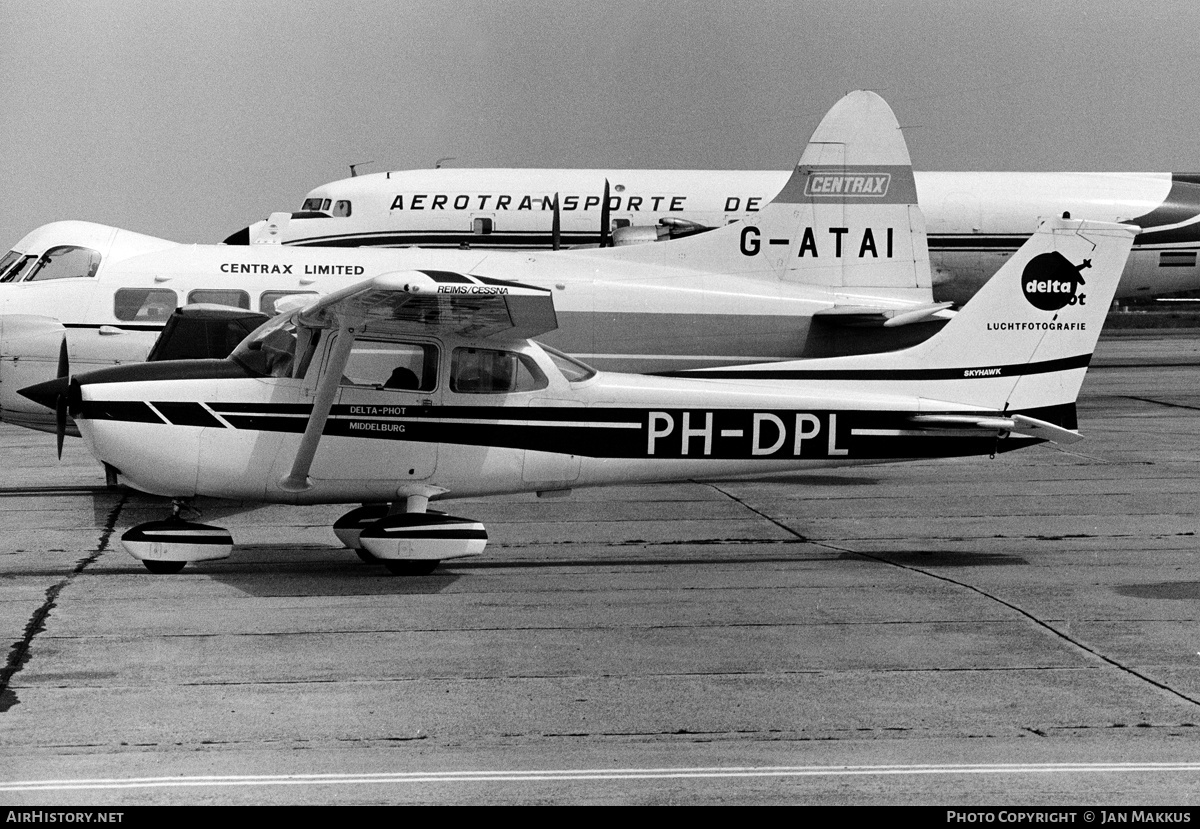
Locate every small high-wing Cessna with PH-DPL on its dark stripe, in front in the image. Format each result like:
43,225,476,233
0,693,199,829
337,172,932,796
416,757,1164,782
26,212,1136,573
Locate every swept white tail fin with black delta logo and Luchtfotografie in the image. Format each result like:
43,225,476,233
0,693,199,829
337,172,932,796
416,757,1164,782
686,218,1138,412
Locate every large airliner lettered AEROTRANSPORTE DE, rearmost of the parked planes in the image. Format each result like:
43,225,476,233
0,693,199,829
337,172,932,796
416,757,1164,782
226,161,1200,304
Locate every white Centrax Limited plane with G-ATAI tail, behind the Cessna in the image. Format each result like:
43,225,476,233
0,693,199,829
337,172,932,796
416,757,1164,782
0,92,949,431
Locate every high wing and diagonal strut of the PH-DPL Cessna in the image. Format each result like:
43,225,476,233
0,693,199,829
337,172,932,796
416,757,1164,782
280,271,558,492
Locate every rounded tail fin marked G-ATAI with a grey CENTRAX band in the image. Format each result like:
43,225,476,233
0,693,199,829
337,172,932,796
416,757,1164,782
585,91,932,302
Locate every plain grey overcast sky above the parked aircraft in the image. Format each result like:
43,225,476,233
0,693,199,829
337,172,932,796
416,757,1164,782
0,0,1200,250
